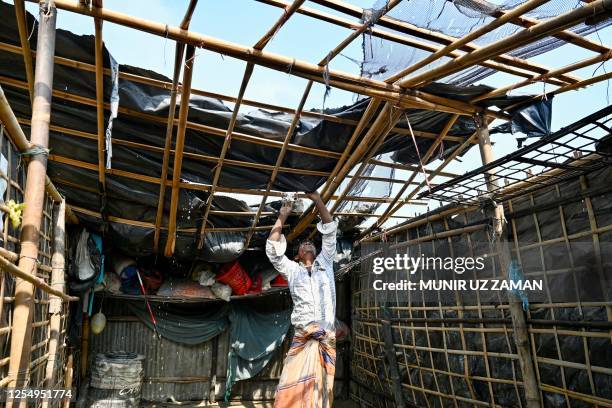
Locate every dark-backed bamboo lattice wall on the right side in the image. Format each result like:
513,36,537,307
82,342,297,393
351,167,612,407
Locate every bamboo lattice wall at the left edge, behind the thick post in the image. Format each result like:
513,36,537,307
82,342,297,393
0,125,67,406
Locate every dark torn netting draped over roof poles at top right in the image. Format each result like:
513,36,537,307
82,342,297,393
361,0,612,85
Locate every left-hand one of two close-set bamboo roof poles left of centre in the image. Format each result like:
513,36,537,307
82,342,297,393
153,0,198,253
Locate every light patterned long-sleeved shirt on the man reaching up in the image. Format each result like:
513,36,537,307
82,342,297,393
266,221,337,330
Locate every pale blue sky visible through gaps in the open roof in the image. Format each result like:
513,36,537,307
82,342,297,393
17,0,612,225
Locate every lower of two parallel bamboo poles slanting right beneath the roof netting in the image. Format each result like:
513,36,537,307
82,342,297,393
257,0,566,85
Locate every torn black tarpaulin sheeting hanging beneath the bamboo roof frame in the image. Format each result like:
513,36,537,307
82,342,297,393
0,2,552,257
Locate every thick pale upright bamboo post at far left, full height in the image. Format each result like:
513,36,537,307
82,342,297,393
8,0,56,387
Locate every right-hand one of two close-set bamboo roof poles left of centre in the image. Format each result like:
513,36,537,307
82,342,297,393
164,46,195,257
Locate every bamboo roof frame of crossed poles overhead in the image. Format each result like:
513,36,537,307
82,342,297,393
0,0,612,255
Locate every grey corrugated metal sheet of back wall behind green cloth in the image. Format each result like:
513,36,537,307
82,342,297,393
90,286,344,402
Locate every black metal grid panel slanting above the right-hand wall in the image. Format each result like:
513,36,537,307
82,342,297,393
419,106,612,204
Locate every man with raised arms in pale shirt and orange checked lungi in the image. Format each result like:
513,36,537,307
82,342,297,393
266,192,337,408
